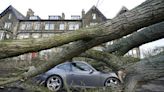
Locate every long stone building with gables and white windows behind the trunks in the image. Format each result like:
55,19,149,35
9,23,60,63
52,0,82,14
0,5,138,58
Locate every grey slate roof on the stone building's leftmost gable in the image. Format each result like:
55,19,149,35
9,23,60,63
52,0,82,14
0,5,25,20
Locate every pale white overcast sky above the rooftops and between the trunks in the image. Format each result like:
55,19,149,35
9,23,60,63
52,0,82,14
0,0,164,55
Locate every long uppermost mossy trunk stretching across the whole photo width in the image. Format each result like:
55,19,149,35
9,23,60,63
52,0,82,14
0,0,164,59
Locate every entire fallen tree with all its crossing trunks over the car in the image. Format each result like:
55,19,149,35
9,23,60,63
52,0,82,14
0,0,164,92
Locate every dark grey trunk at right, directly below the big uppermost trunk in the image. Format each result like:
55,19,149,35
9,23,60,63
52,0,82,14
107,22,164,55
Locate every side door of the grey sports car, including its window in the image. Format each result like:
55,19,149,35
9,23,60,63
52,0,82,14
68,62,100,87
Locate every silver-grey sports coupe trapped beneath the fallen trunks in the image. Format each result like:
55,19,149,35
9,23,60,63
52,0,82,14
36,61,120,91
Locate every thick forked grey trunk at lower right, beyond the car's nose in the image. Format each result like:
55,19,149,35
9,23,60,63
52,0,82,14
124,53,164,92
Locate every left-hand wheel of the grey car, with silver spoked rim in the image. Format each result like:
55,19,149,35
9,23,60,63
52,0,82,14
46,75,63,91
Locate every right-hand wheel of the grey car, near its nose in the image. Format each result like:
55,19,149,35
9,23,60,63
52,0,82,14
104,77,120,87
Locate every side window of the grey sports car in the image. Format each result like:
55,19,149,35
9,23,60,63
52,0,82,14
71,62,92,71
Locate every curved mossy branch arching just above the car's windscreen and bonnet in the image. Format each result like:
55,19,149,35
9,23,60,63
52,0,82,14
80,50,139,71
